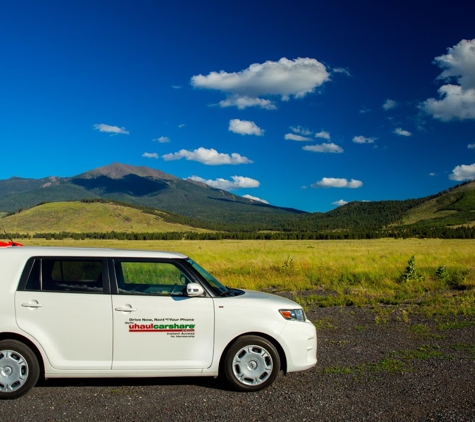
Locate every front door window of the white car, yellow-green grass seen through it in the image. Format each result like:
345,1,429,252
114,260,190,296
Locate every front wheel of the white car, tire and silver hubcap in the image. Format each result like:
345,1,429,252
223,336,280,392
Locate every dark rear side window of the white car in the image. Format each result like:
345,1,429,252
25,258,104,293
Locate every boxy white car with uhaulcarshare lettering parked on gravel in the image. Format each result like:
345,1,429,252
0,245,317,399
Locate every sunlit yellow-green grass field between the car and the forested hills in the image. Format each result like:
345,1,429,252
24,239,475,314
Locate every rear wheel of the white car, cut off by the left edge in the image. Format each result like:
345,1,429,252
0,340,40,400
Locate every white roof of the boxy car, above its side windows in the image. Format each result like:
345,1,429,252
0,246,187,259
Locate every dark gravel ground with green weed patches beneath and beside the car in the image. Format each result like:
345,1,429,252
0,308,475,422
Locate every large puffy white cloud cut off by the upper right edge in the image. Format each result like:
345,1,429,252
420,39,475,121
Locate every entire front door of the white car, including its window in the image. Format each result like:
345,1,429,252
112,259,214,371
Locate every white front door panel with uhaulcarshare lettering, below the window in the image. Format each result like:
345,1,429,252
112,296,214,370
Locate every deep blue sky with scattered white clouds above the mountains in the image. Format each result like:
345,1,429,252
0,0,475,212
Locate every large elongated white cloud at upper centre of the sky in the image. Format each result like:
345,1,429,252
191,57,330,109
